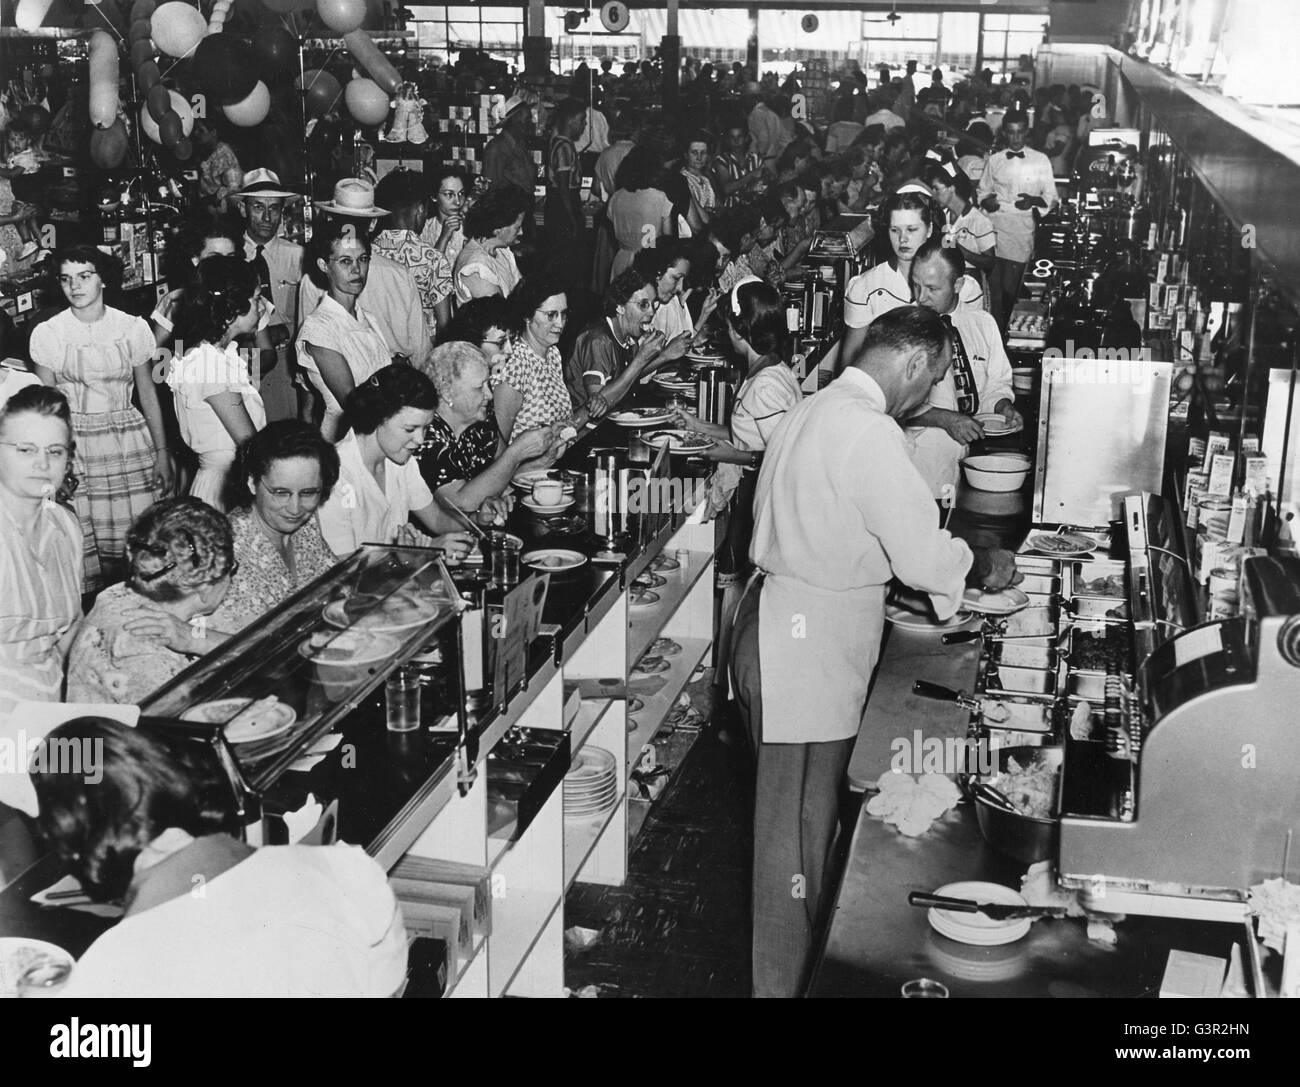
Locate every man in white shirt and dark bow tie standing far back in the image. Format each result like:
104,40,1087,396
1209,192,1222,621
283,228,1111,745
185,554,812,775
979,109,1057,329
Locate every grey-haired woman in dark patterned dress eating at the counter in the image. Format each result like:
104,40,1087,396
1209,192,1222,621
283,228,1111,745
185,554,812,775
416,343,554,510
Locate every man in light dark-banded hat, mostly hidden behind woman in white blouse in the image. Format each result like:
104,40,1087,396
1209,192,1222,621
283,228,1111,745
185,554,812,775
298,177,429,361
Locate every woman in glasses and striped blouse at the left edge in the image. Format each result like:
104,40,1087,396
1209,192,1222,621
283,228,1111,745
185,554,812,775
0,384,82,711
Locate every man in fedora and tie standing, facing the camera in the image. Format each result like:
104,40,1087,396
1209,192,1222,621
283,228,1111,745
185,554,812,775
230,169,303,423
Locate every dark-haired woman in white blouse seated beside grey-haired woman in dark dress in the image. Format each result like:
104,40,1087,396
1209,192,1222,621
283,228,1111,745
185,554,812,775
316,365,471,558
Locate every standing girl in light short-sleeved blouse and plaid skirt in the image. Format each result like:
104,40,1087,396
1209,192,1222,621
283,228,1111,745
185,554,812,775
30,246,176,592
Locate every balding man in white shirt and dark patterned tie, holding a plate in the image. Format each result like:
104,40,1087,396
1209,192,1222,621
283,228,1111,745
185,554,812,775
907,238,1023,503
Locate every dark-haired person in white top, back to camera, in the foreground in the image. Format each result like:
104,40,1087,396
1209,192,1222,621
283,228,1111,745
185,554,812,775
31,716,407,997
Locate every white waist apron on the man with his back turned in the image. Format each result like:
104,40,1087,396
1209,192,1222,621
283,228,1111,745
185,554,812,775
750,575,888,744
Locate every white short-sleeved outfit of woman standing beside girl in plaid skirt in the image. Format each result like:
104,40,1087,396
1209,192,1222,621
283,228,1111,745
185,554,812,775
166,343,267,512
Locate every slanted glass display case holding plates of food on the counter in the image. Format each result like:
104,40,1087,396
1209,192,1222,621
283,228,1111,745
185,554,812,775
140,545,464,793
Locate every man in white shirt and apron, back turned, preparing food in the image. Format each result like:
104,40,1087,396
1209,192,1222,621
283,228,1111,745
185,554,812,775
732,306,1017,996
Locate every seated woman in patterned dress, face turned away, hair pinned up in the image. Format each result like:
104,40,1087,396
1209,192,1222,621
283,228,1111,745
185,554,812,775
68,497,235,703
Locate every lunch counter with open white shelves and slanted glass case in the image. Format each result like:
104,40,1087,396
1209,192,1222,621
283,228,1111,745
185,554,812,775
0,385,715,996
